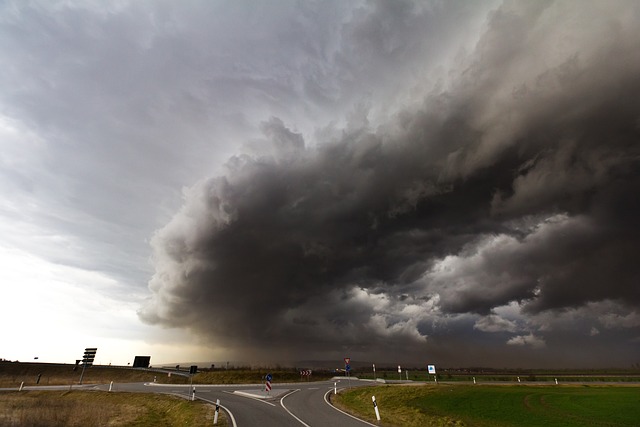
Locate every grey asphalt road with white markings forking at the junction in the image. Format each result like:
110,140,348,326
1,378,374,427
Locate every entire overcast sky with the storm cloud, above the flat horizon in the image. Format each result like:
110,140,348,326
0,0,640,367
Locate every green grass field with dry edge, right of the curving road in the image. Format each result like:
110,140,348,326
334,385,640,427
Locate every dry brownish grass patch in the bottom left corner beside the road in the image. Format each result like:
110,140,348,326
0,391,227,427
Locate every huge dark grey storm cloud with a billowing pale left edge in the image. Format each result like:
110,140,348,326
140,2,640,363
